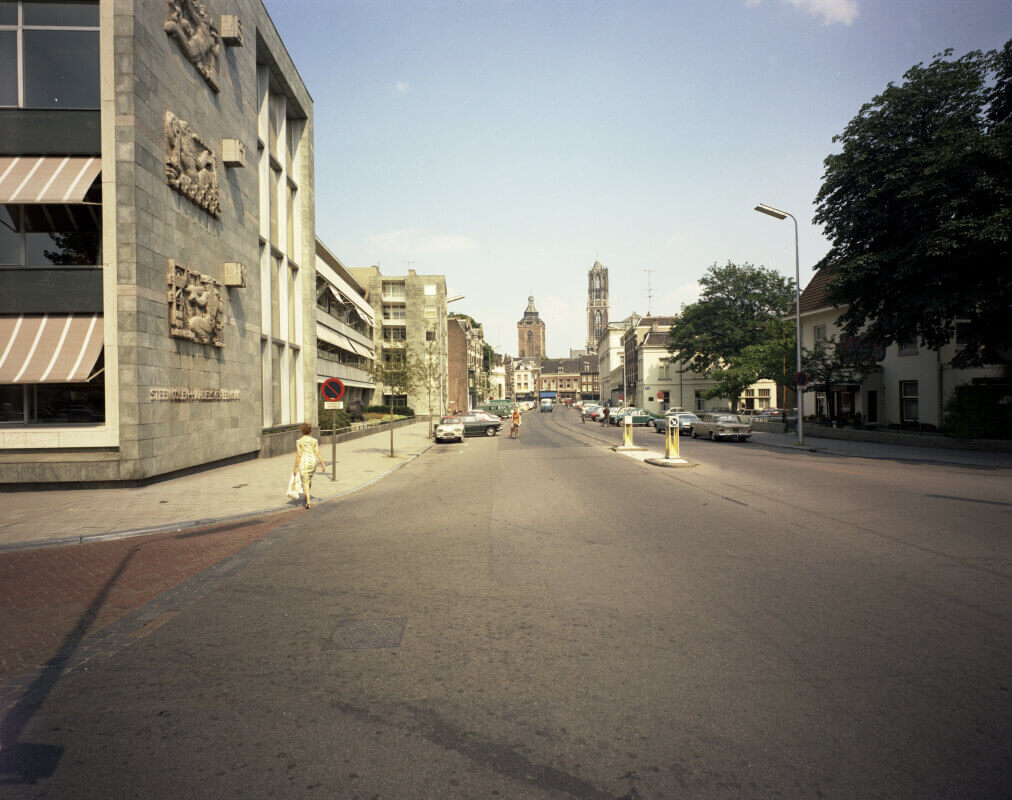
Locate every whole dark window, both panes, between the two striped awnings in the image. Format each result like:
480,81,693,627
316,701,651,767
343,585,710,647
0,204,102,267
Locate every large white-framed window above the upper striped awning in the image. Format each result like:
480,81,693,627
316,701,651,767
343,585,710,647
0,2,99,108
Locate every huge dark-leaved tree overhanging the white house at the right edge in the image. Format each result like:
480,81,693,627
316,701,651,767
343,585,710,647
815,40,1012,366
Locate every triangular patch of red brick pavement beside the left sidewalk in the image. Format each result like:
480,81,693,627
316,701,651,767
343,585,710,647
0,511,304,687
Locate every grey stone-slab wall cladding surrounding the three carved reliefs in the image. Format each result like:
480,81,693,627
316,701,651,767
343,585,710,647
108,0,315,479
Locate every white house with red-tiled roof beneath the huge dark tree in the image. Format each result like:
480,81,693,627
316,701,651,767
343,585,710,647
800,269,1012,427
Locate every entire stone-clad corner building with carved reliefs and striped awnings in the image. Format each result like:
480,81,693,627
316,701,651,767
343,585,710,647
0,0,317,483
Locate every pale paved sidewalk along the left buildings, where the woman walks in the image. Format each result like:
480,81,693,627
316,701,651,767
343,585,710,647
0,422,430,550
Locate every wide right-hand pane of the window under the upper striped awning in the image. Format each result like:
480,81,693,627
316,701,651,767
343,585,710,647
24,205,101,267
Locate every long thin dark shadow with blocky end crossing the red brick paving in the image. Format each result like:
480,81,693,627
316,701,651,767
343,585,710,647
0,547,140,786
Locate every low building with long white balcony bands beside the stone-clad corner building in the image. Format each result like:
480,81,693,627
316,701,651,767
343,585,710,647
316,239,375,408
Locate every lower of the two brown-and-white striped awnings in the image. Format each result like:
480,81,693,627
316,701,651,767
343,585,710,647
0,314,103,383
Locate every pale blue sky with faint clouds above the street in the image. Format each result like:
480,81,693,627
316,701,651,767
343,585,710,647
265,0,1012,357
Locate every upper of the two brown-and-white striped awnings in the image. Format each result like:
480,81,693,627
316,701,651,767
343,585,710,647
0,156,102,203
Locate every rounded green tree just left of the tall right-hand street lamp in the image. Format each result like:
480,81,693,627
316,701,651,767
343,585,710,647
668,261,794,375
